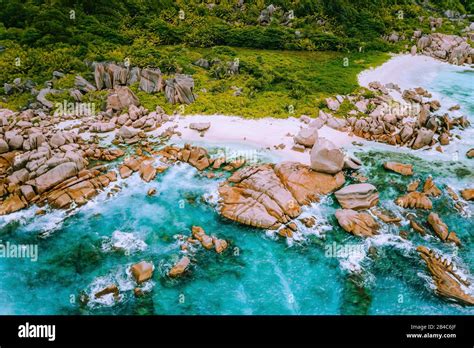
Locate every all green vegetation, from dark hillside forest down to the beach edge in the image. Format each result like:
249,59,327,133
0,0,473,117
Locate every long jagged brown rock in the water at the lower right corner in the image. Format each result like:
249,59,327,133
416,246,474,306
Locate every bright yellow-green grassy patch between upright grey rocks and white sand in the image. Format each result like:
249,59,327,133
123,47,389,118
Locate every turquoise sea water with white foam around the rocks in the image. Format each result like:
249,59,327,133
0,66,474,315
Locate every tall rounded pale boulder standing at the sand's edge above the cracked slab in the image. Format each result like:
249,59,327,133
310,138,344,174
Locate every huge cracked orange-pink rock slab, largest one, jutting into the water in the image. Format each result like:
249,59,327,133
219,162,344,229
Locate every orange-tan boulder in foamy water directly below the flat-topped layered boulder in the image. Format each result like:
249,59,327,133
336,209,379,237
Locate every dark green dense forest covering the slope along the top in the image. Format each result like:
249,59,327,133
0,0,474,117
